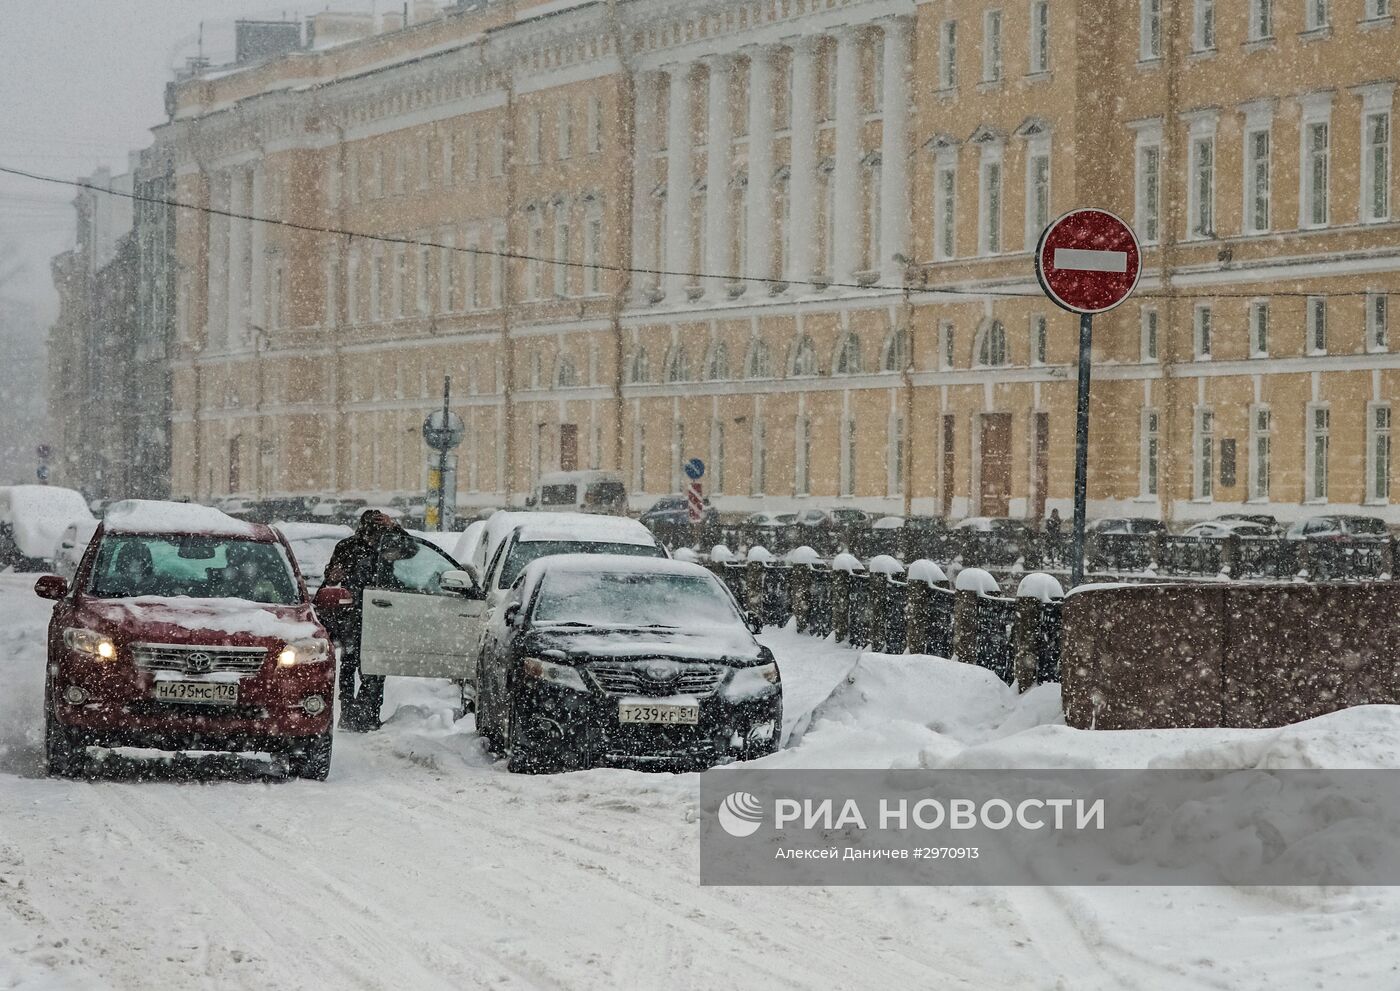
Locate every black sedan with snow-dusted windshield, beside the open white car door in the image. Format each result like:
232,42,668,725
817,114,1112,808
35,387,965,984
476,554,783,771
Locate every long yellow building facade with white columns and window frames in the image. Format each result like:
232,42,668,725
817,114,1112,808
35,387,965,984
158,0,1400,522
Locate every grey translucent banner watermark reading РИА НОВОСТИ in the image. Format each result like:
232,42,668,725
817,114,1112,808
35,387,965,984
700,768,1400,885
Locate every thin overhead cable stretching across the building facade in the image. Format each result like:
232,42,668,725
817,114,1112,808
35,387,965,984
0,165,1394,300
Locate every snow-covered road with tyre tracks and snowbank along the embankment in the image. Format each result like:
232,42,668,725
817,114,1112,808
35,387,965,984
0,575,1400,991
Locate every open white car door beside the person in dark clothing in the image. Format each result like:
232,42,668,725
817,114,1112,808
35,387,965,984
360,535,486,682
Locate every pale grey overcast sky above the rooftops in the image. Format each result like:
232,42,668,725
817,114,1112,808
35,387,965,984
0,0,380,322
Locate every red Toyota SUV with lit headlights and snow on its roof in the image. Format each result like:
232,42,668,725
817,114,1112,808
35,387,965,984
35,500,346,780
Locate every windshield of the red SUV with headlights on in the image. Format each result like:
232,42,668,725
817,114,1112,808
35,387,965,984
88,533,301,606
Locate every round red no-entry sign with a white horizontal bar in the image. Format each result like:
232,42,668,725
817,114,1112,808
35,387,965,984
1036,210,1142,314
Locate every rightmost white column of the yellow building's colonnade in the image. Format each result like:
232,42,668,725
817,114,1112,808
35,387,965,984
876,17,913,284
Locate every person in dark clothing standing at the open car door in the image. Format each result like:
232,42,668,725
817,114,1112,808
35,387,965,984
322,509,414,732
